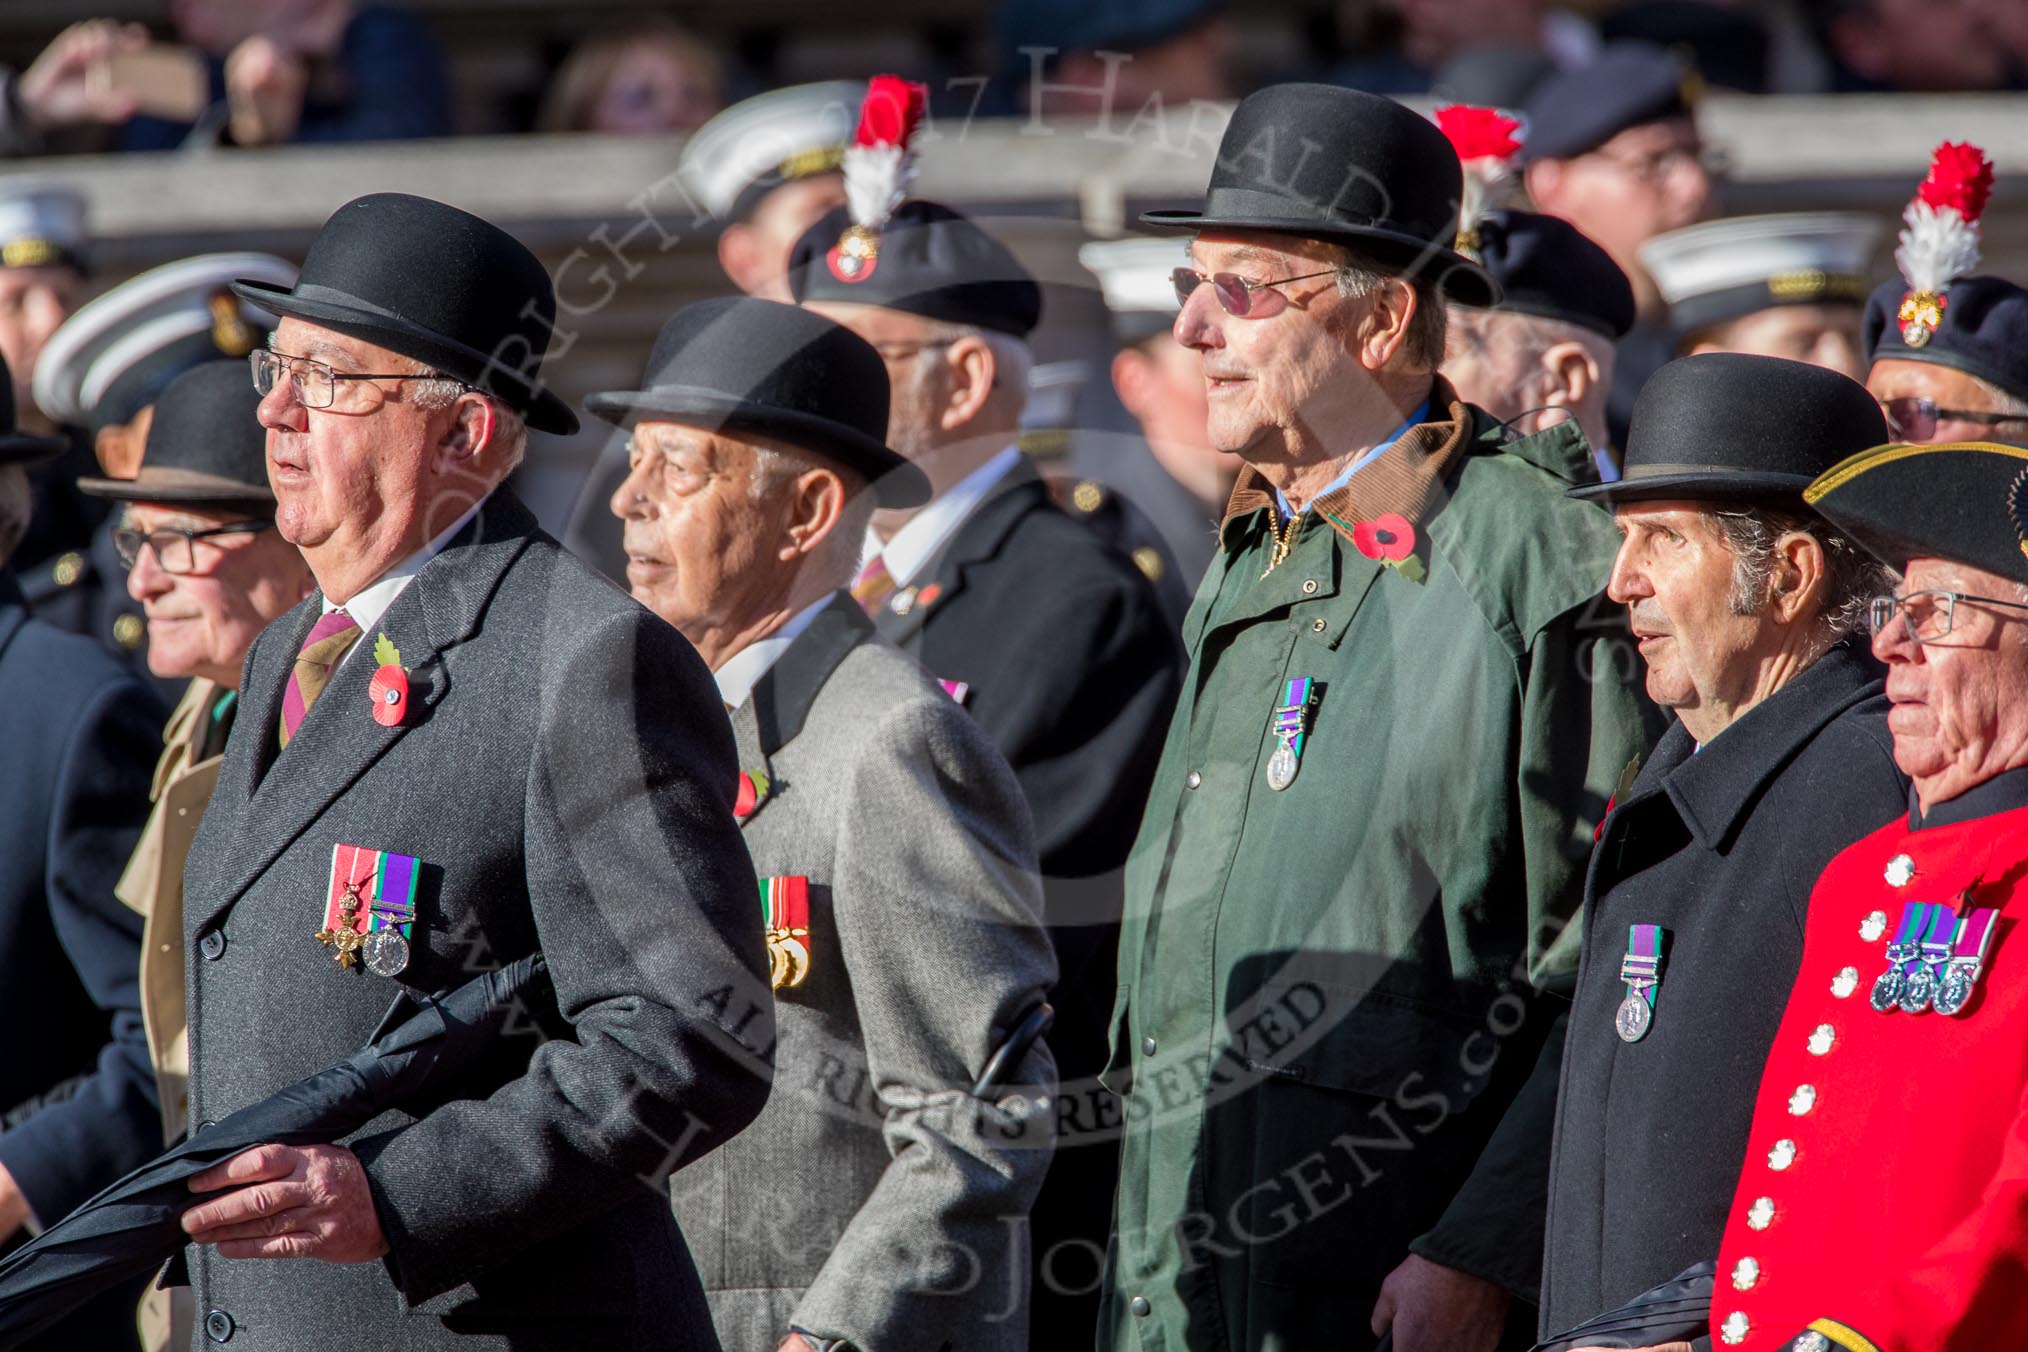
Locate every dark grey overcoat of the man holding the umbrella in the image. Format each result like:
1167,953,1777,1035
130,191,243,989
185,491,773,1352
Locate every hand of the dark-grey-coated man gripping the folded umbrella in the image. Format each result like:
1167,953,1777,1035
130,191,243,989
183,1145,387,1263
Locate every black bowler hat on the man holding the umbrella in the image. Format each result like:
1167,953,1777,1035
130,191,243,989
233,193,578,434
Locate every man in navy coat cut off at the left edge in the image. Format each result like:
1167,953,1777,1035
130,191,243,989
0,352,162,1352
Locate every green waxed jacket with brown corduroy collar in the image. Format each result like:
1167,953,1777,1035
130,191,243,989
1099,391,1655,1352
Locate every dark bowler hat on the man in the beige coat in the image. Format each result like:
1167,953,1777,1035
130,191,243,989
77,359,274,513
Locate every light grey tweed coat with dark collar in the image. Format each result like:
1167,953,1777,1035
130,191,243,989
671,594,1057,1352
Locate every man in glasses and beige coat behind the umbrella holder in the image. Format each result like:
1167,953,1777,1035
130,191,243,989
77,359,316,1348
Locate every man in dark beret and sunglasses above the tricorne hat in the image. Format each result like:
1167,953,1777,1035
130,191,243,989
1866,276,2028,446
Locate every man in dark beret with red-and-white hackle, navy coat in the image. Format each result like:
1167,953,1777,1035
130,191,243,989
791,190,1180,1346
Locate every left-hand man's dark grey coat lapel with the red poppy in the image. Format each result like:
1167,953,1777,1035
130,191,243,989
193,491,535,928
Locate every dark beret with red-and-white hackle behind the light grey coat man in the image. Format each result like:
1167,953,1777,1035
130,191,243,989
789,199,1042,339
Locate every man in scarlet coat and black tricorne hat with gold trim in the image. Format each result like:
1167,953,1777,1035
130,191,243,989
1712,439,2028,1352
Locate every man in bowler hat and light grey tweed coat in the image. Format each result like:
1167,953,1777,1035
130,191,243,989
588,300,1057,1352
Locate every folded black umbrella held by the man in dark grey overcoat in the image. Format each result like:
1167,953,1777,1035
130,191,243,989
0,953,556,1350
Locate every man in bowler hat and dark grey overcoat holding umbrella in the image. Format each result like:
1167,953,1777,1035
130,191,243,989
166,195,773,1350
